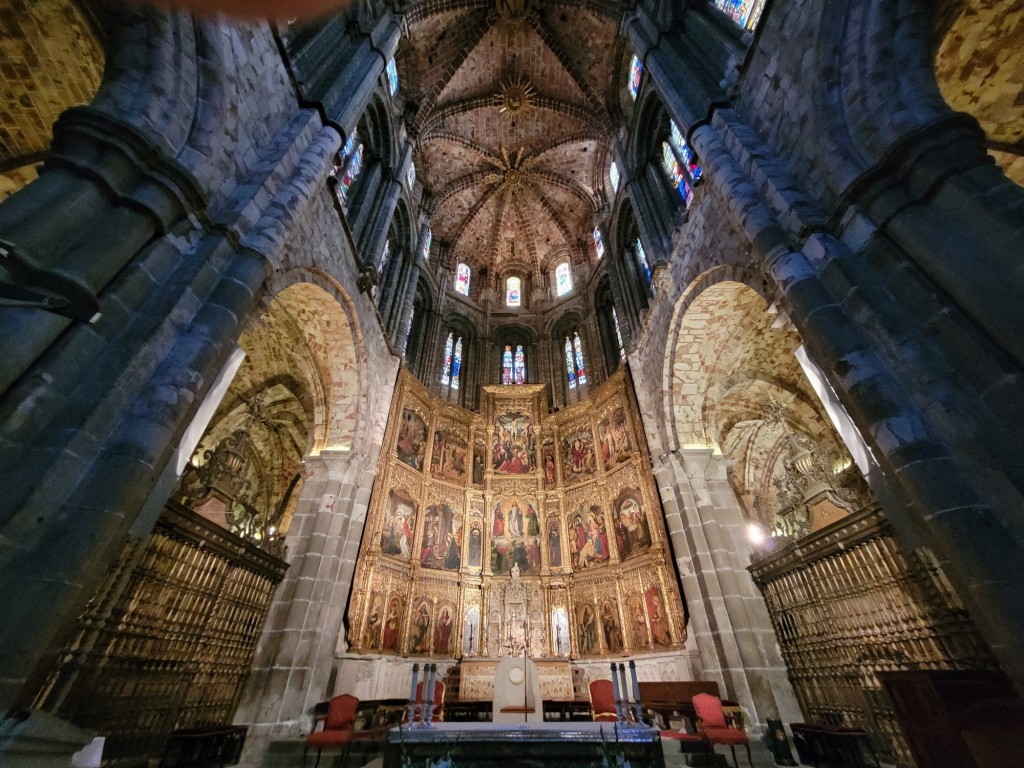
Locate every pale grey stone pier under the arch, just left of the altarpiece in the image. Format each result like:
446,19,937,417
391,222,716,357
236,452,376,766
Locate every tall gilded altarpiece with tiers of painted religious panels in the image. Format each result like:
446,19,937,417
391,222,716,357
348,371,686,663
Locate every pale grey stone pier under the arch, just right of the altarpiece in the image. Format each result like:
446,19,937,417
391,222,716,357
654,449,802,727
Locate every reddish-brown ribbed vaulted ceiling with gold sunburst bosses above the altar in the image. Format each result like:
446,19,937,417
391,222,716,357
396,0,624,276
